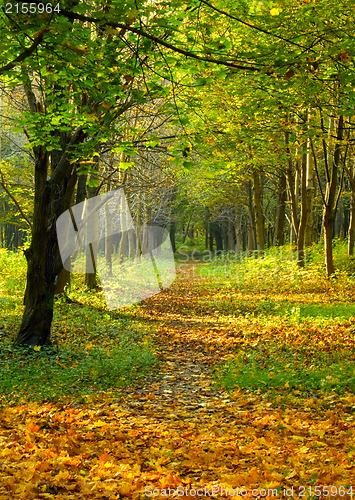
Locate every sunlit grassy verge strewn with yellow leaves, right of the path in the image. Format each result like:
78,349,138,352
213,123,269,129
193,242,355,400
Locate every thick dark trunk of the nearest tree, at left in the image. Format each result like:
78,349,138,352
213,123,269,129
15,143,76,346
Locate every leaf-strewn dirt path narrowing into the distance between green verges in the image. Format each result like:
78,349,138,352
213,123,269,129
118,265,238,417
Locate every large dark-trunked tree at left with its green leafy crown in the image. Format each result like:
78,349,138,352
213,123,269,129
0,0,182,345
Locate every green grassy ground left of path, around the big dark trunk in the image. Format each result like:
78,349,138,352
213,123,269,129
0,250,157,404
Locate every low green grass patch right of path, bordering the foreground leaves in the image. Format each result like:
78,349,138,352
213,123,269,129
214,343,355,397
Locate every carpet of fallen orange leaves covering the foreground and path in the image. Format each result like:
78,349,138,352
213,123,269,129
0,265,355,500
